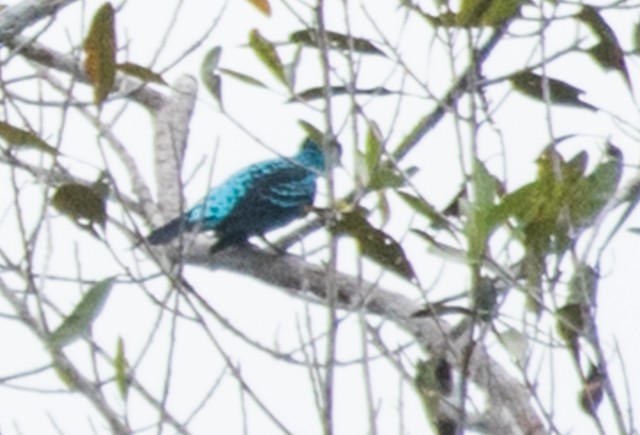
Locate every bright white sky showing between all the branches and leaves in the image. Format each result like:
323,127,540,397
0,0,640,435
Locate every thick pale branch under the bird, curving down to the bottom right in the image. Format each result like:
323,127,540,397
183,243,544,435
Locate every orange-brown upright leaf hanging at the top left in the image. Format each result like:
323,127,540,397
84,3,116,105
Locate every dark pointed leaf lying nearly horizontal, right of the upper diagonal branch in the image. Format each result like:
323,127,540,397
509,71,597,110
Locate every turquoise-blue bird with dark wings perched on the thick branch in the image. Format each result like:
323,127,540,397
146,137,327,253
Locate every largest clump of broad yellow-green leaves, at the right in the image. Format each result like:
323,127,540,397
488,145,622,312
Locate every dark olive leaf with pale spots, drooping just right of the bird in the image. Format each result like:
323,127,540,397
331,210,415,280
